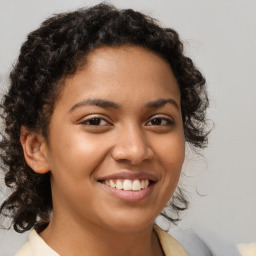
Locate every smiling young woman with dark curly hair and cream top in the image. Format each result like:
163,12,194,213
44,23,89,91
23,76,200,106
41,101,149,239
1,4,208,256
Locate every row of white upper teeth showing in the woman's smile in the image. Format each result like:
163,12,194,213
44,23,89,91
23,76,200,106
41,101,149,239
104,179,149,191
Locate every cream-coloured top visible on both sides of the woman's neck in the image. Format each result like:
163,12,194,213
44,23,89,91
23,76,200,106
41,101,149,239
15,225,188,256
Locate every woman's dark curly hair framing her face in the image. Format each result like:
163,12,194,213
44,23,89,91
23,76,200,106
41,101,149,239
0,4,208,232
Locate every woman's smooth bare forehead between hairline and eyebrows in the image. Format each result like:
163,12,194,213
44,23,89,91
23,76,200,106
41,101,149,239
56,45,180,109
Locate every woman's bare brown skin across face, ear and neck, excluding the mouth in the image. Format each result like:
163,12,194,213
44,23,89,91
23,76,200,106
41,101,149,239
21,46,185,256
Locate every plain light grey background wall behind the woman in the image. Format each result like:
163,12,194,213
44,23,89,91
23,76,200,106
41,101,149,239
0,0,256,256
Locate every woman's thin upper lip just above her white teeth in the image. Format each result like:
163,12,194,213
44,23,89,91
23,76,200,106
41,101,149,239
97,171,158,182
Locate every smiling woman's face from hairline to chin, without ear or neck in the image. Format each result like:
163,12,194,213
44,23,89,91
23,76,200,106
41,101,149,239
43,46,184,232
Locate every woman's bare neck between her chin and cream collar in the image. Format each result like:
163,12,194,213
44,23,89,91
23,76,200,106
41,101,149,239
40,212,163,256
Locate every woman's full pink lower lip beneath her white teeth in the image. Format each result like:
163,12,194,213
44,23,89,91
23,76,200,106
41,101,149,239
100,183,155,202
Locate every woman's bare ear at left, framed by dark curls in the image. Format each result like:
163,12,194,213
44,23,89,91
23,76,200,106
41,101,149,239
20,126,50,174
